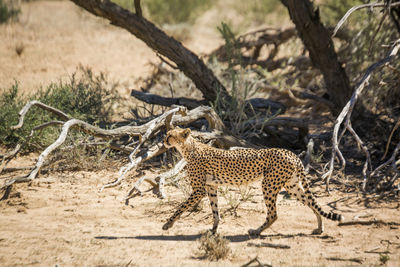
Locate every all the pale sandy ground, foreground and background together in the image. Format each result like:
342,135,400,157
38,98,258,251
0,1,400,266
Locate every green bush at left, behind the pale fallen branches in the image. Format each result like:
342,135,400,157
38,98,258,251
0,68,116,151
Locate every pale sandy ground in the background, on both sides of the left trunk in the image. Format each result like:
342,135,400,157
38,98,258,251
0,1,222,95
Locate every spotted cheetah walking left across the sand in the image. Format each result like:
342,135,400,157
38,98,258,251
162,128,343,236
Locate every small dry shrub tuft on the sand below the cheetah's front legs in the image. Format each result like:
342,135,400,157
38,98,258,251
199,231,231,261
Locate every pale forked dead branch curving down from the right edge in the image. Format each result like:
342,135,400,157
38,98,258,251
322,39,400,192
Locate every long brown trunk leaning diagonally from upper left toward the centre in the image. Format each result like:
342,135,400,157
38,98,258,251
71,0,229,101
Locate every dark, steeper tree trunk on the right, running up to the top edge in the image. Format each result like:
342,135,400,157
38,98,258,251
281,0,352,114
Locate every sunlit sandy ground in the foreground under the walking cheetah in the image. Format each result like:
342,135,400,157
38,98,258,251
0,166,400,266
